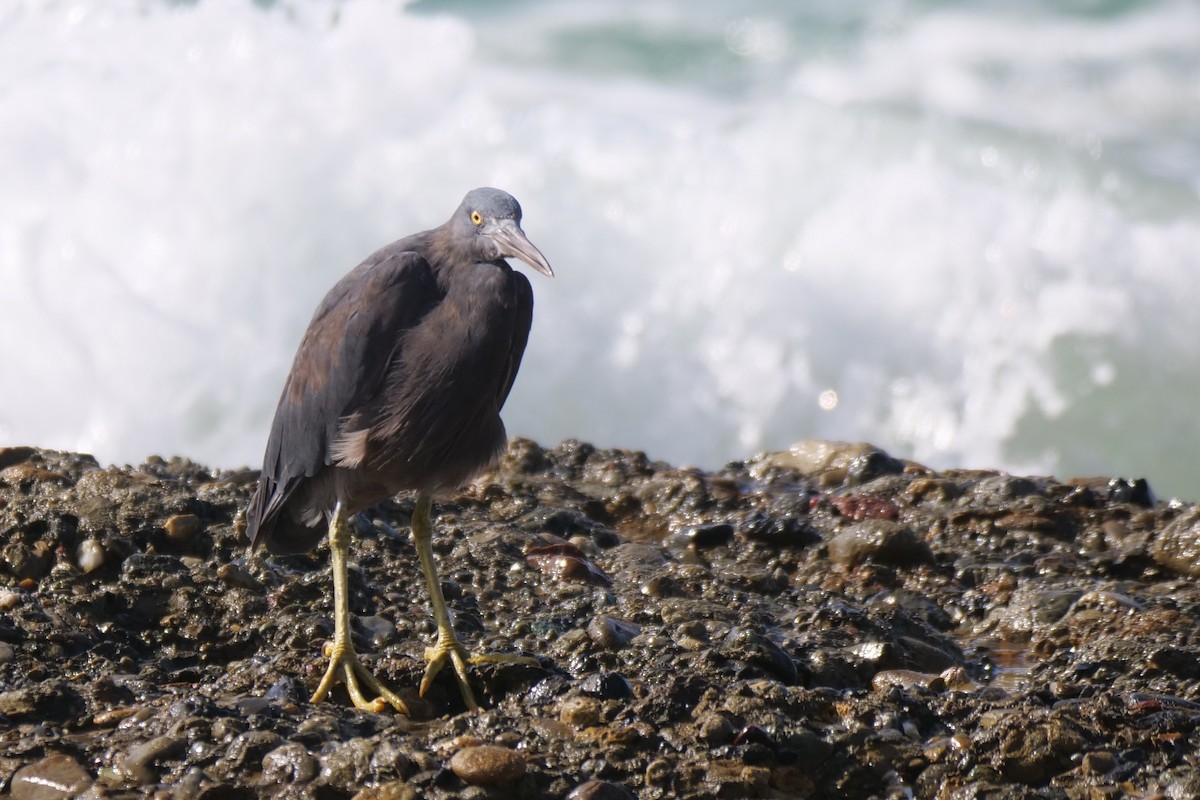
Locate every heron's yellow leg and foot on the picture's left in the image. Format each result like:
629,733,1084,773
312,503,408,714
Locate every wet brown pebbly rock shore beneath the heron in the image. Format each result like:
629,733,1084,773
0,440,1200,800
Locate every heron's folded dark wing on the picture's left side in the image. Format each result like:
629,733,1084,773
246,250,438,547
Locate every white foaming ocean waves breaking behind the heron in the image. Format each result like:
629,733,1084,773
0,0,1200,500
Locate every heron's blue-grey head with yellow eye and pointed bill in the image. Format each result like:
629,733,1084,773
450,188,554,277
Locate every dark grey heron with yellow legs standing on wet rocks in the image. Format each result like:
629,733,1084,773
246,188,554,714
